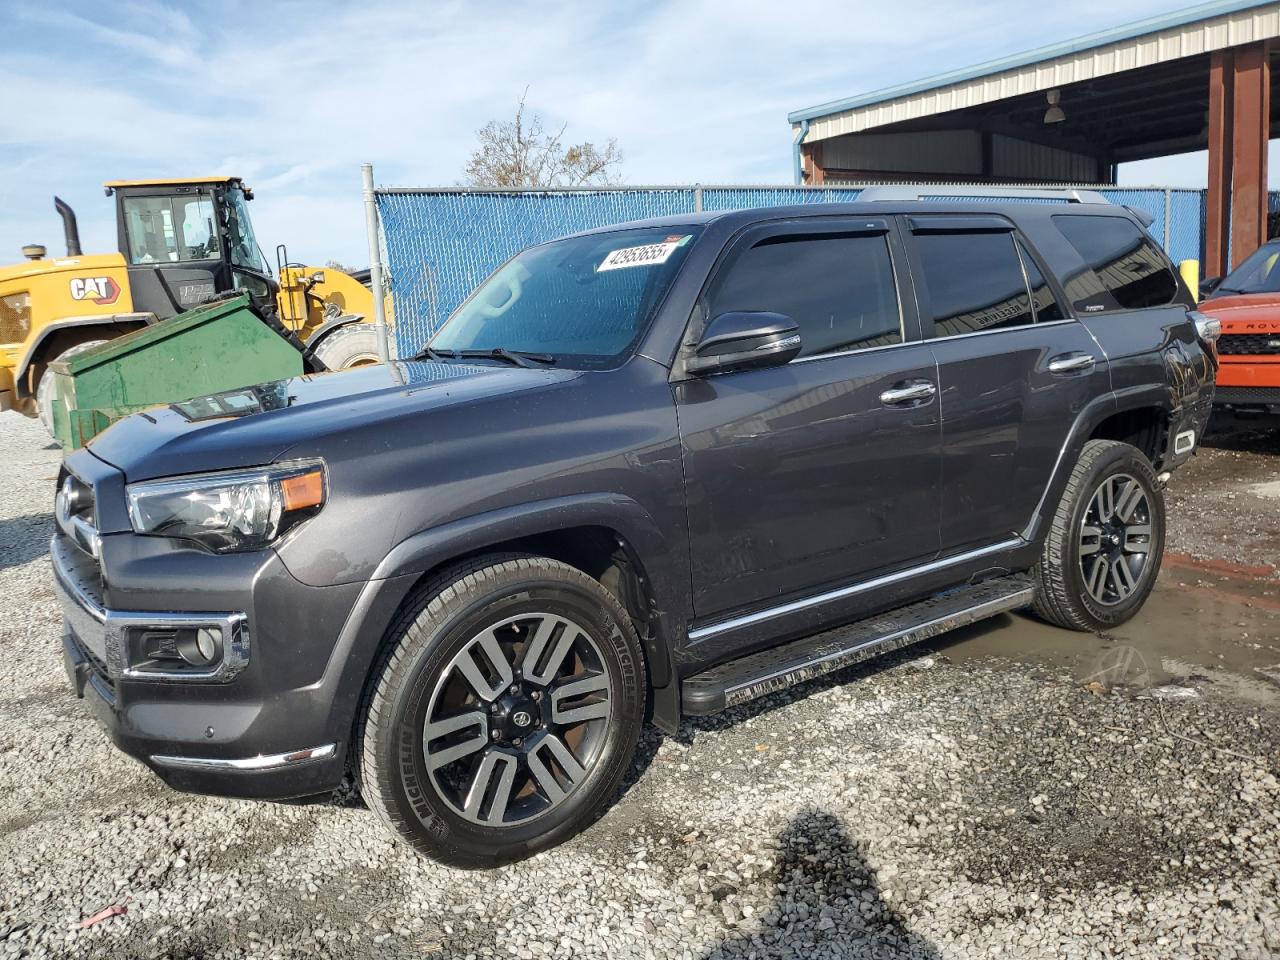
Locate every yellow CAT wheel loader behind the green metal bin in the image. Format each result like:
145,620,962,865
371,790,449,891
0,177,379,429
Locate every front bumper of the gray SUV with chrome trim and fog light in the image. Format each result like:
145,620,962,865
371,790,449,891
51,522,352,800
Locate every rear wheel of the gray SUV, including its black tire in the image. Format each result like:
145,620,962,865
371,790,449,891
1034,440,1165,630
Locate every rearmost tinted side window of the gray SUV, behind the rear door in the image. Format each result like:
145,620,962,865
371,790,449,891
1053,216,1178,312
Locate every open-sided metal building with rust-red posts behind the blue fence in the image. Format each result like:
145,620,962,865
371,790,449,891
788,0,1280,275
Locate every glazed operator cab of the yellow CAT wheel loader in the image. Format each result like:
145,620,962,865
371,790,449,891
105,177,278,320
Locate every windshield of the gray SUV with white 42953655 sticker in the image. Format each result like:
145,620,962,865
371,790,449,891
430,227,700,369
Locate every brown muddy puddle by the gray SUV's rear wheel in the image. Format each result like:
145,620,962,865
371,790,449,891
922,556,1280,709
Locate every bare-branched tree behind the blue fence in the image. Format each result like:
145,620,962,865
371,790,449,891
466,88,622,187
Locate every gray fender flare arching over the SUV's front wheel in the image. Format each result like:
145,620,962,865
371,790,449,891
326,493,682,737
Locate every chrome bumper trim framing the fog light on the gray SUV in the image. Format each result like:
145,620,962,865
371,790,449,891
49,536,250,684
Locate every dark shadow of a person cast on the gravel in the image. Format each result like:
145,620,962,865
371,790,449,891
700,810,942,960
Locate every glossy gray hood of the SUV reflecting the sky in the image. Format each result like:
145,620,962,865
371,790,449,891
88,361,580,481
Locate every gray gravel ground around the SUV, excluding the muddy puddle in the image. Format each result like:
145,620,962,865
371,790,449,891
0,415,1280,960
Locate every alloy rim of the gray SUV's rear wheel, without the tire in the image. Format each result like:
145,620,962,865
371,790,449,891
1079,474,1152,607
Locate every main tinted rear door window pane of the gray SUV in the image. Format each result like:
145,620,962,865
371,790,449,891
915,233,1034,337
